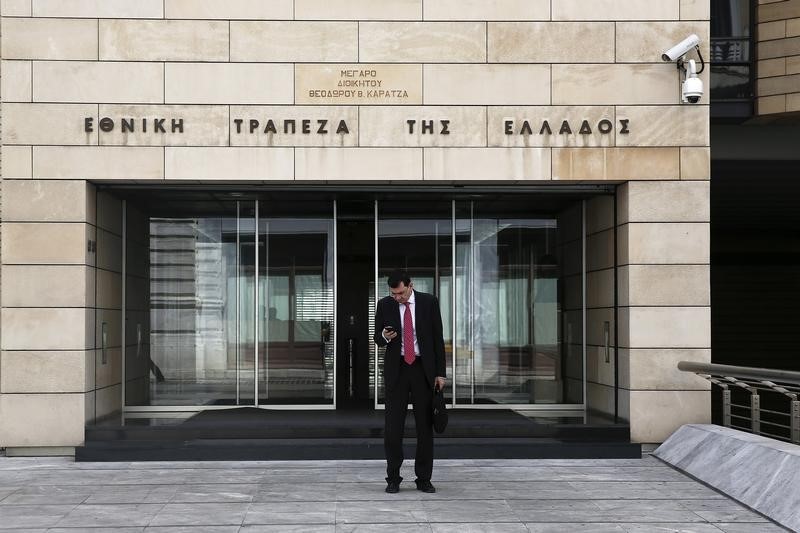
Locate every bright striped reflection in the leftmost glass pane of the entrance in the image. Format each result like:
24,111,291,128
141,204,255,405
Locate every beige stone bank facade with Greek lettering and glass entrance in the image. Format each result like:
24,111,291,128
0,0,711,453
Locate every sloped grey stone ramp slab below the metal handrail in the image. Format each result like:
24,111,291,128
654,424,800,531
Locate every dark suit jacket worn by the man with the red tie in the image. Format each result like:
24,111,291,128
374,291,447,389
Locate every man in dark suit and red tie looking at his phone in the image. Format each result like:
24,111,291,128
375,271,445,493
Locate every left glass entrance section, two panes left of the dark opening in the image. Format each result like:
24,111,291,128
124,195,335,411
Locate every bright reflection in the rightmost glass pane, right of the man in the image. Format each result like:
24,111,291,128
456,204,562,404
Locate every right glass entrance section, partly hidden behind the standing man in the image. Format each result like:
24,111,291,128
371,195,585,409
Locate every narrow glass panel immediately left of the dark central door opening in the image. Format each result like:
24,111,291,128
258,213,334,405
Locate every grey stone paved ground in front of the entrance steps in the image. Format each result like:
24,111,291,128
0,456,785,533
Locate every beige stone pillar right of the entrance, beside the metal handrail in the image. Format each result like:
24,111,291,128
616,177,711,442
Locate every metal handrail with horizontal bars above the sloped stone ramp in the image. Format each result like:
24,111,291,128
678,361,800,444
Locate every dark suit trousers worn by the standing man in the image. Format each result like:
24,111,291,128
383,358,433,482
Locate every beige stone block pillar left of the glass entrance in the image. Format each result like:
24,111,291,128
0,181,97,447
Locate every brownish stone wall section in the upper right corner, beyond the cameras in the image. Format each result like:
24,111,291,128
756,0,800,115
